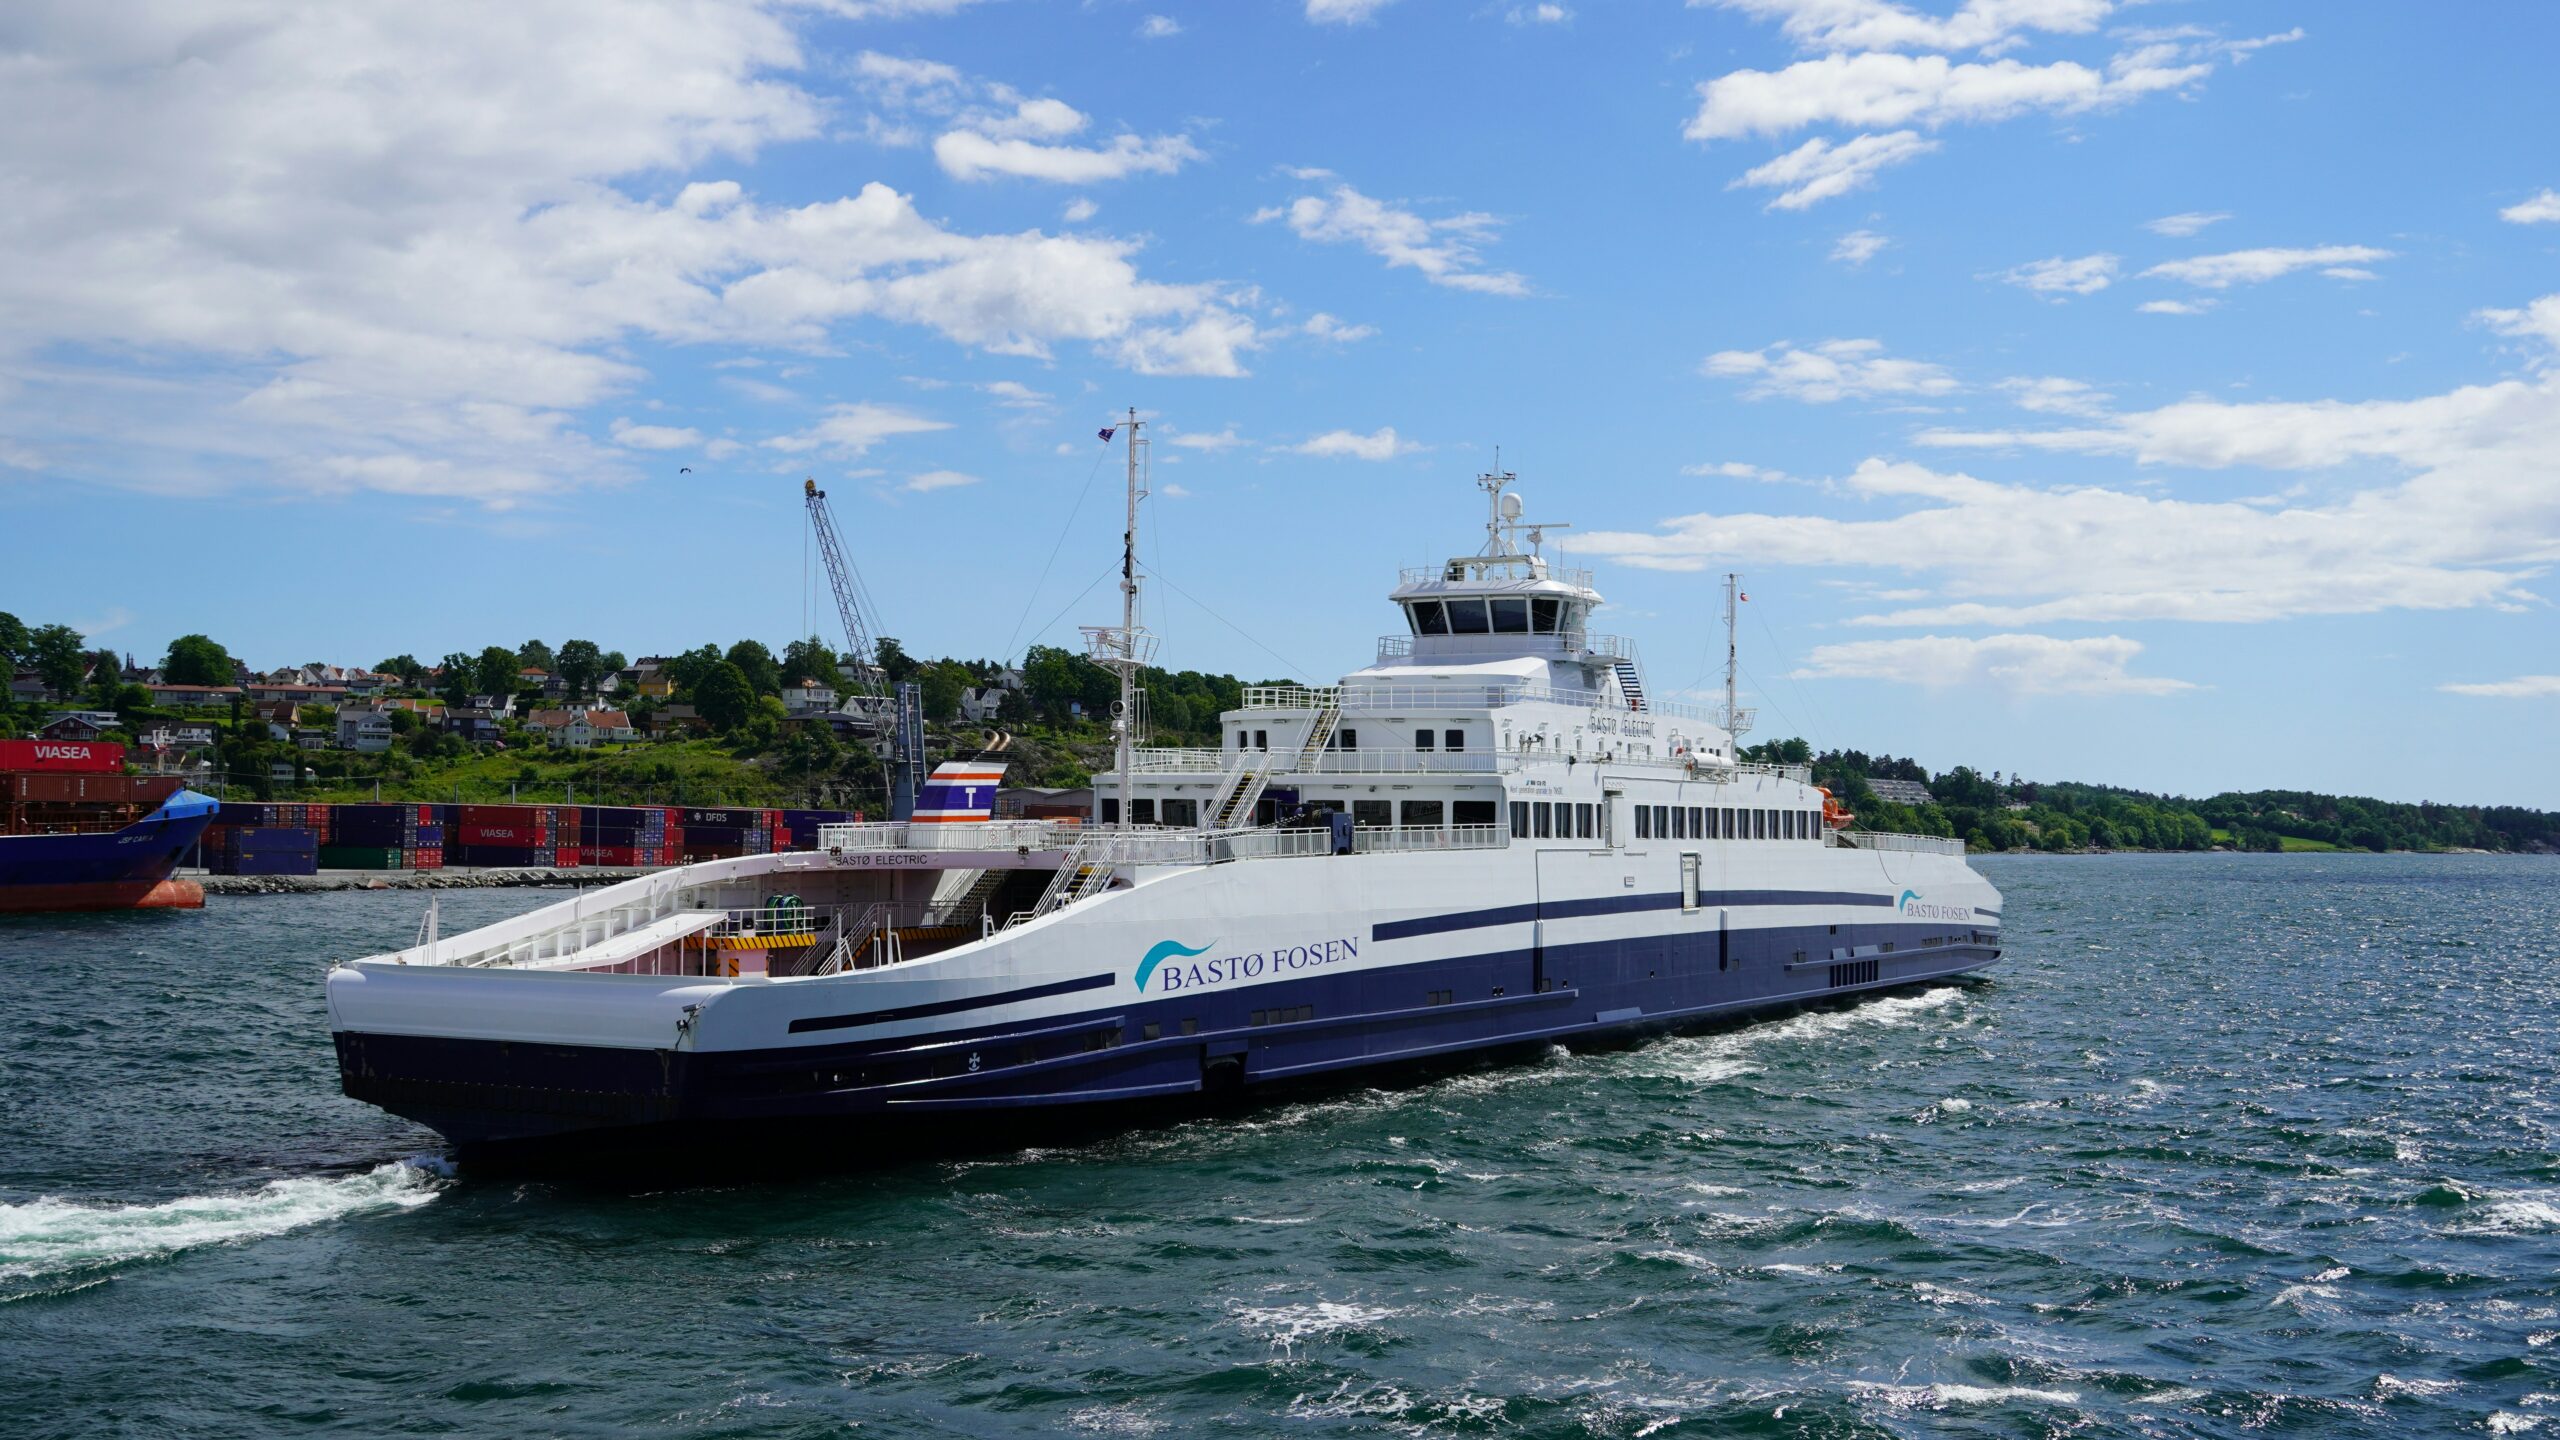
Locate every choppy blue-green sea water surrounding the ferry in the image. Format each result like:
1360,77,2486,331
0,856,2560,1437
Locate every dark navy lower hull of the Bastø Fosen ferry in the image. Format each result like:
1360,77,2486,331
335,925,1999,1166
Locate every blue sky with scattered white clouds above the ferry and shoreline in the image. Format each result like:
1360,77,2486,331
0,0,2560,807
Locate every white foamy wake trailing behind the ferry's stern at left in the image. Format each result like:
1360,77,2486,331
0,1161,448,1281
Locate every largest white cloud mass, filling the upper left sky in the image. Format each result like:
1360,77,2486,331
0,0,1257,505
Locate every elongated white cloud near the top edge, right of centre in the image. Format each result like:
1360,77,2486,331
1682,51,2212,143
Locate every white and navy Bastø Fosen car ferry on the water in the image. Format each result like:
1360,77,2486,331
328,459,1999,1158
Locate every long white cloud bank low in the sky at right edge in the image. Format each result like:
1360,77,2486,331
1567,297,2560,625
